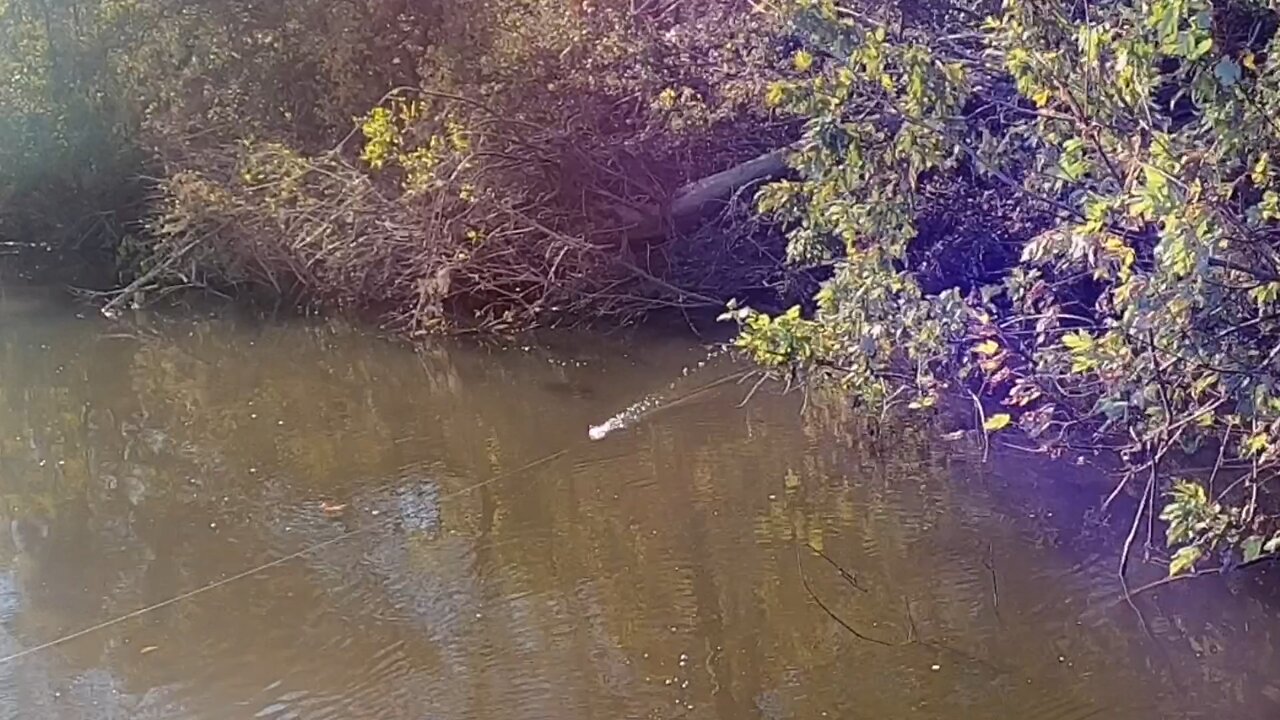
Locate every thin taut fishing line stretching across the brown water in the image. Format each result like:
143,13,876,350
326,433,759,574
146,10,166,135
0,361,745,665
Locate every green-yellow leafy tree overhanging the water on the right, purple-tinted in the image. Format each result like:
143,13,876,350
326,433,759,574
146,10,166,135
740,0,1280,573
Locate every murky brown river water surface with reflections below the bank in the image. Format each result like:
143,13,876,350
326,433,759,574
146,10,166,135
0,283,1280,720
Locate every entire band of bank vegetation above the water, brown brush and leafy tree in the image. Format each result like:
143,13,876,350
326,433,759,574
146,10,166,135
0,0,1280,574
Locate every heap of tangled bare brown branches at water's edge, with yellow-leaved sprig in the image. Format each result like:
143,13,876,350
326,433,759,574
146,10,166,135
132,79,798,336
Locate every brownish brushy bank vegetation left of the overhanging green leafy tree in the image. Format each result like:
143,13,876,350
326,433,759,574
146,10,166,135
0,0,812,333
